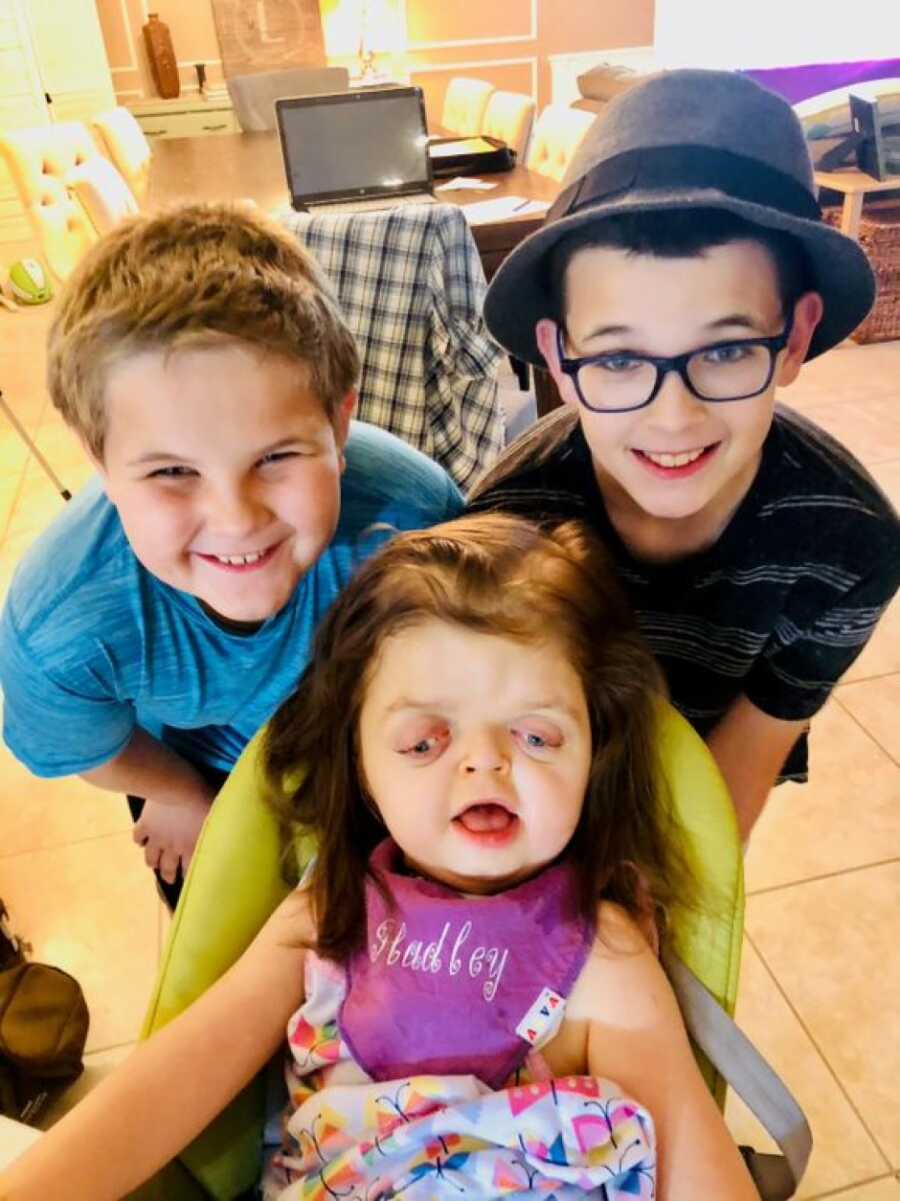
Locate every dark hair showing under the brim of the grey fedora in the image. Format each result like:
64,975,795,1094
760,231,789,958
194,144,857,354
546,209,810,327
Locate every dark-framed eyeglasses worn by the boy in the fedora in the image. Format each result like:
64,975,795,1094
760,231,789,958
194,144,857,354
556,313,793,413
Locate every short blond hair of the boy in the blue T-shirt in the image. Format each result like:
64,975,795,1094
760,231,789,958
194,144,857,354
47,204,359,459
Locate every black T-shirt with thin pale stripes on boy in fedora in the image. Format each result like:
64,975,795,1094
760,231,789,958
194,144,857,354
470,406,900,779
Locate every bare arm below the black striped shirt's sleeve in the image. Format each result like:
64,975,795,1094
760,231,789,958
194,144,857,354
707,697,809,842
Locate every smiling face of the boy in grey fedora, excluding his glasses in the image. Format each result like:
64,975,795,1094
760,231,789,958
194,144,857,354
537,241,819,557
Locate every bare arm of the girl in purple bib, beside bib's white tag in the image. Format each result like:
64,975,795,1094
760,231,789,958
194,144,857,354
576,904,758,1201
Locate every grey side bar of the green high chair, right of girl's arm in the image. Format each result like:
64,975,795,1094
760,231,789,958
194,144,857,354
662,950,812,1201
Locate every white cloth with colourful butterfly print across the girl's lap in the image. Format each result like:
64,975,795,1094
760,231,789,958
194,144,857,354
263,1076,655,1201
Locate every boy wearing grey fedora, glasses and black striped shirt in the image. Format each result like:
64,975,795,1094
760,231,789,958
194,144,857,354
470,70,900,838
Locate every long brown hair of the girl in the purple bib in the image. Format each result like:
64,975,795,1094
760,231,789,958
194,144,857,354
263,514,692,962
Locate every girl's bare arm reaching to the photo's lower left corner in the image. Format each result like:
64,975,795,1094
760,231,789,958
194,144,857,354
0,891,311,1201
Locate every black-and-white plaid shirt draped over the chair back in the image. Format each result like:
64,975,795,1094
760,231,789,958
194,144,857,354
279,204,503,490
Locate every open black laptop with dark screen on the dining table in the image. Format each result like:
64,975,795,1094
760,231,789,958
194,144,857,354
275,88,434,211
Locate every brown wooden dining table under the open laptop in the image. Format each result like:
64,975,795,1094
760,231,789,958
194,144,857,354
144,133,559,279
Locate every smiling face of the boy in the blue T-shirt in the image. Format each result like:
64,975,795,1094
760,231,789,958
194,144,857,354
97,342,352,622
